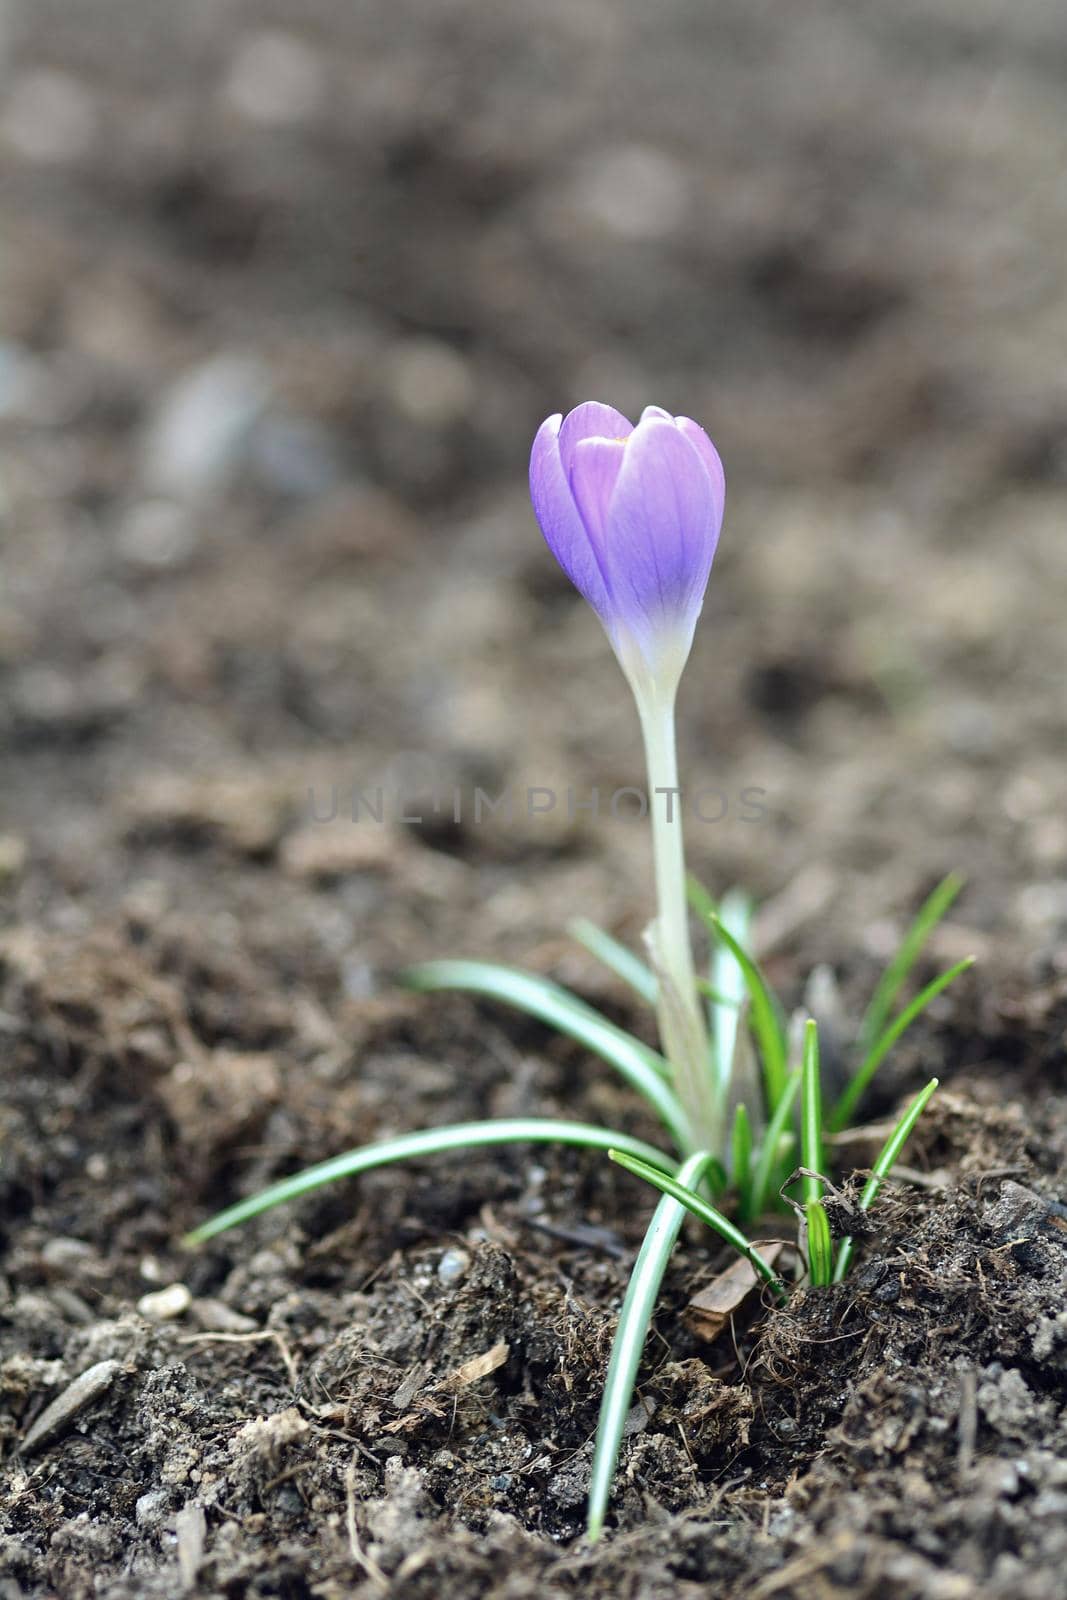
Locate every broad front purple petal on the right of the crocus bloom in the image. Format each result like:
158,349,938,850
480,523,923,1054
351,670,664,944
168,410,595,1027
605,416,720,638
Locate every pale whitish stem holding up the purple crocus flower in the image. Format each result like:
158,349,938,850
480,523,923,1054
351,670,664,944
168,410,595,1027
637,688,723,1150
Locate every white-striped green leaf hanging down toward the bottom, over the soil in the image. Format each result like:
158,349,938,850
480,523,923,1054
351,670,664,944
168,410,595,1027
585,1150,712,1539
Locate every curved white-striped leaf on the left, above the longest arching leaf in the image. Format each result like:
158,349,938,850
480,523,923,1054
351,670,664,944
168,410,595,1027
402,962,693,1150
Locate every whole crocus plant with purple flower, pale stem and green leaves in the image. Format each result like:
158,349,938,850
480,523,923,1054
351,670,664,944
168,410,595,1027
189,402,971,1536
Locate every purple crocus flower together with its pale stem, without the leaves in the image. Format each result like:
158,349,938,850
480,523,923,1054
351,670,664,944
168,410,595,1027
530,400,726,1149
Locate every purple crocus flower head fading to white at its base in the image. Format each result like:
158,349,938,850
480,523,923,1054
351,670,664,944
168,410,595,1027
530,400,726,696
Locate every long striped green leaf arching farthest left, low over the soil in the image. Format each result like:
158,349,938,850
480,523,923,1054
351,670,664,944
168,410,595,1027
184,1117,675,1245
